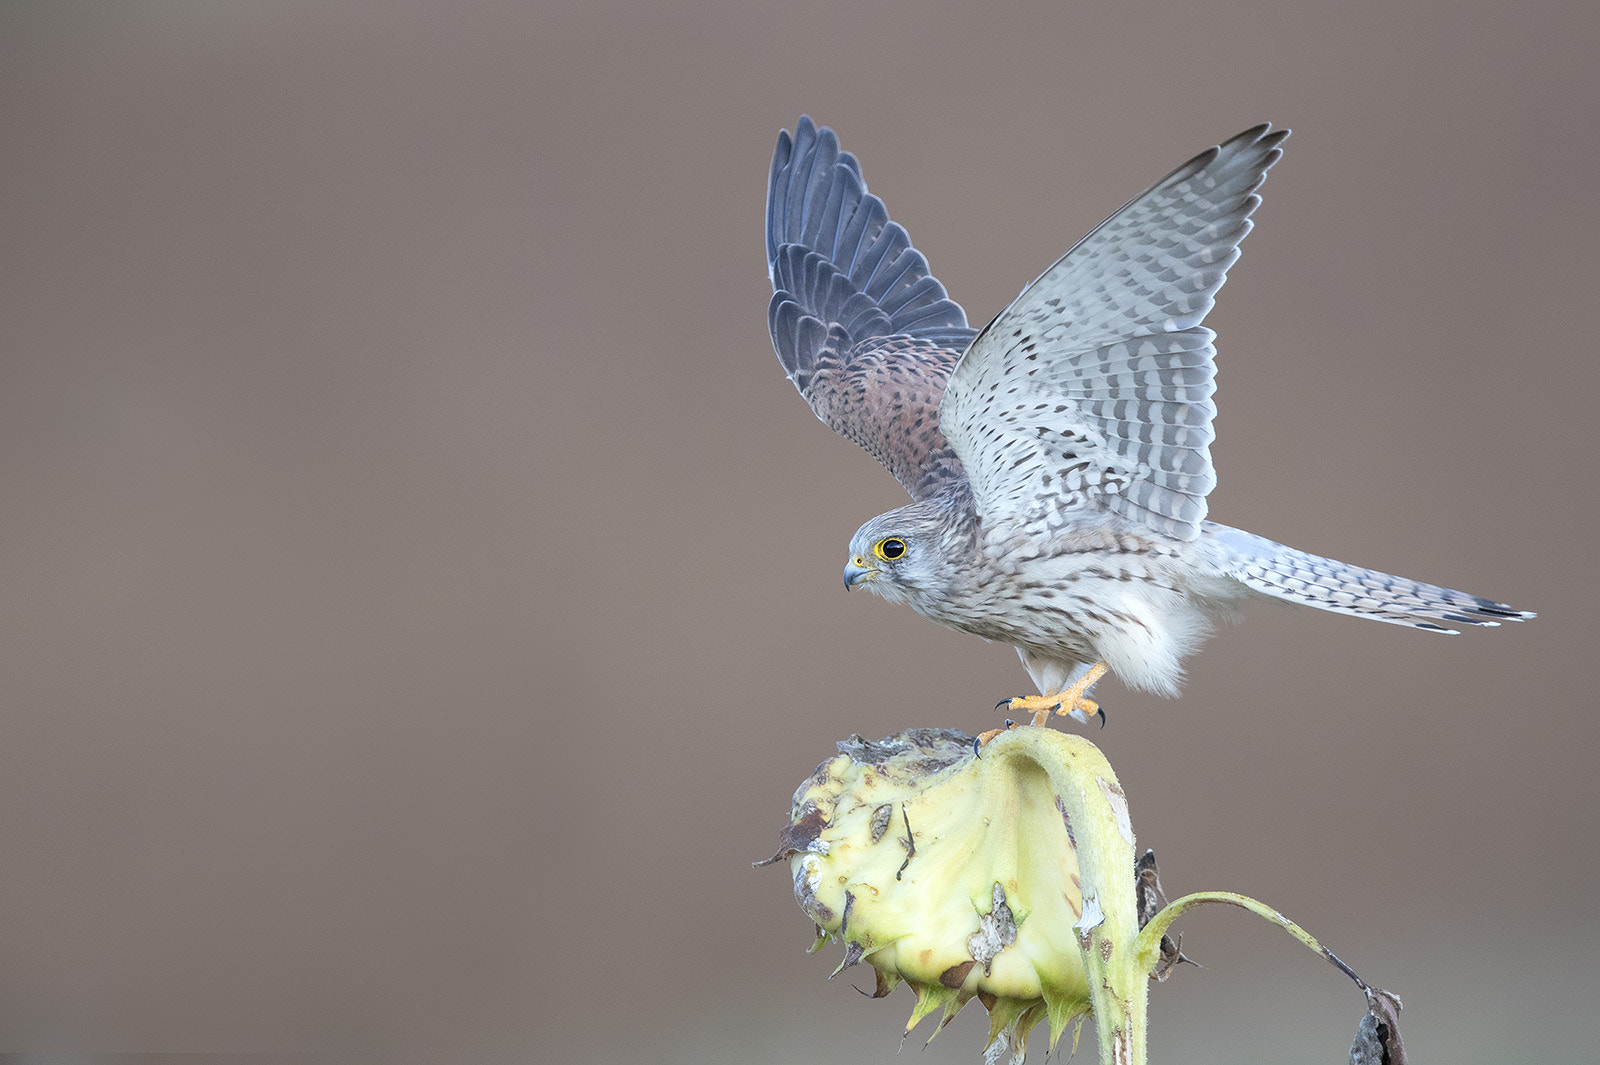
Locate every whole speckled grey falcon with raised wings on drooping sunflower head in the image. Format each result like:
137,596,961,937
766,117,1533,724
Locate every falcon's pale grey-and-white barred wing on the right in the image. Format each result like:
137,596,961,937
942,125,1290,540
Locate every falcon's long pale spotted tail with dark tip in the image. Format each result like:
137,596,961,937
1210,525,1534,633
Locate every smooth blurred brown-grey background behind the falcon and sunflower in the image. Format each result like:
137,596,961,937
0,0,1600,1065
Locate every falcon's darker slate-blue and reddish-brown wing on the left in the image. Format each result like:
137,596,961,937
766,117,976,499
